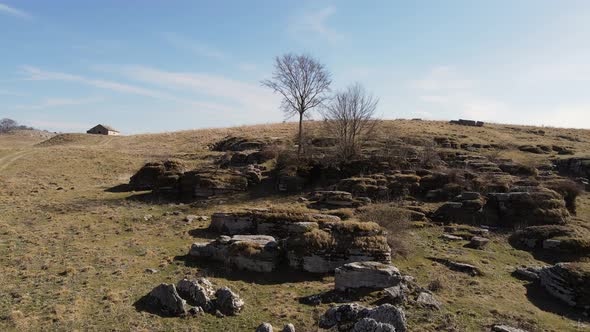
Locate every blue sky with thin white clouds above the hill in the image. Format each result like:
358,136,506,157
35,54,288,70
0,0,590,133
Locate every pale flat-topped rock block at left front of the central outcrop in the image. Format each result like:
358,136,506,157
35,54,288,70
189,235,281,272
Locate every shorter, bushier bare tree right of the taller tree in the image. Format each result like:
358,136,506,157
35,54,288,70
323,83,379,158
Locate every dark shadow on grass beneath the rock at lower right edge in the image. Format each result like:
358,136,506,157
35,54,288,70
525,282,590,323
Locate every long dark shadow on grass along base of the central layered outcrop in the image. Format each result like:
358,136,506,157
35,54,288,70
174,255,325,285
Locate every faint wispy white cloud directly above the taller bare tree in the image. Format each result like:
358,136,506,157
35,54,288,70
289,6,344,43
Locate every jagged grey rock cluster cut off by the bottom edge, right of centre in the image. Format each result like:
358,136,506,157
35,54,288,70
319,303,407,332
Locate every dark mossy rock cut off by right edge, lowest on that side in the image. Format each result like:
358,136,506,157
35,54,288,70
539,263,590,310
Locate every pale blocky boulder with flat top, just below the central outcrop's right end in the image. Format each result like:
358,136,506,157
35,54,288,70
334,262,401,291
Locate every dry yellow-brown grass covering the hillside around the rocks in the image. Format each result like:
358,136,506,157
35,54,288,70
0,120,590,332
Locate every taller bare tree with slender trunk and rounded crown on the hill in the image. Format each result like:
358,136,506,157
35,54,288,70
261,54,332,155
